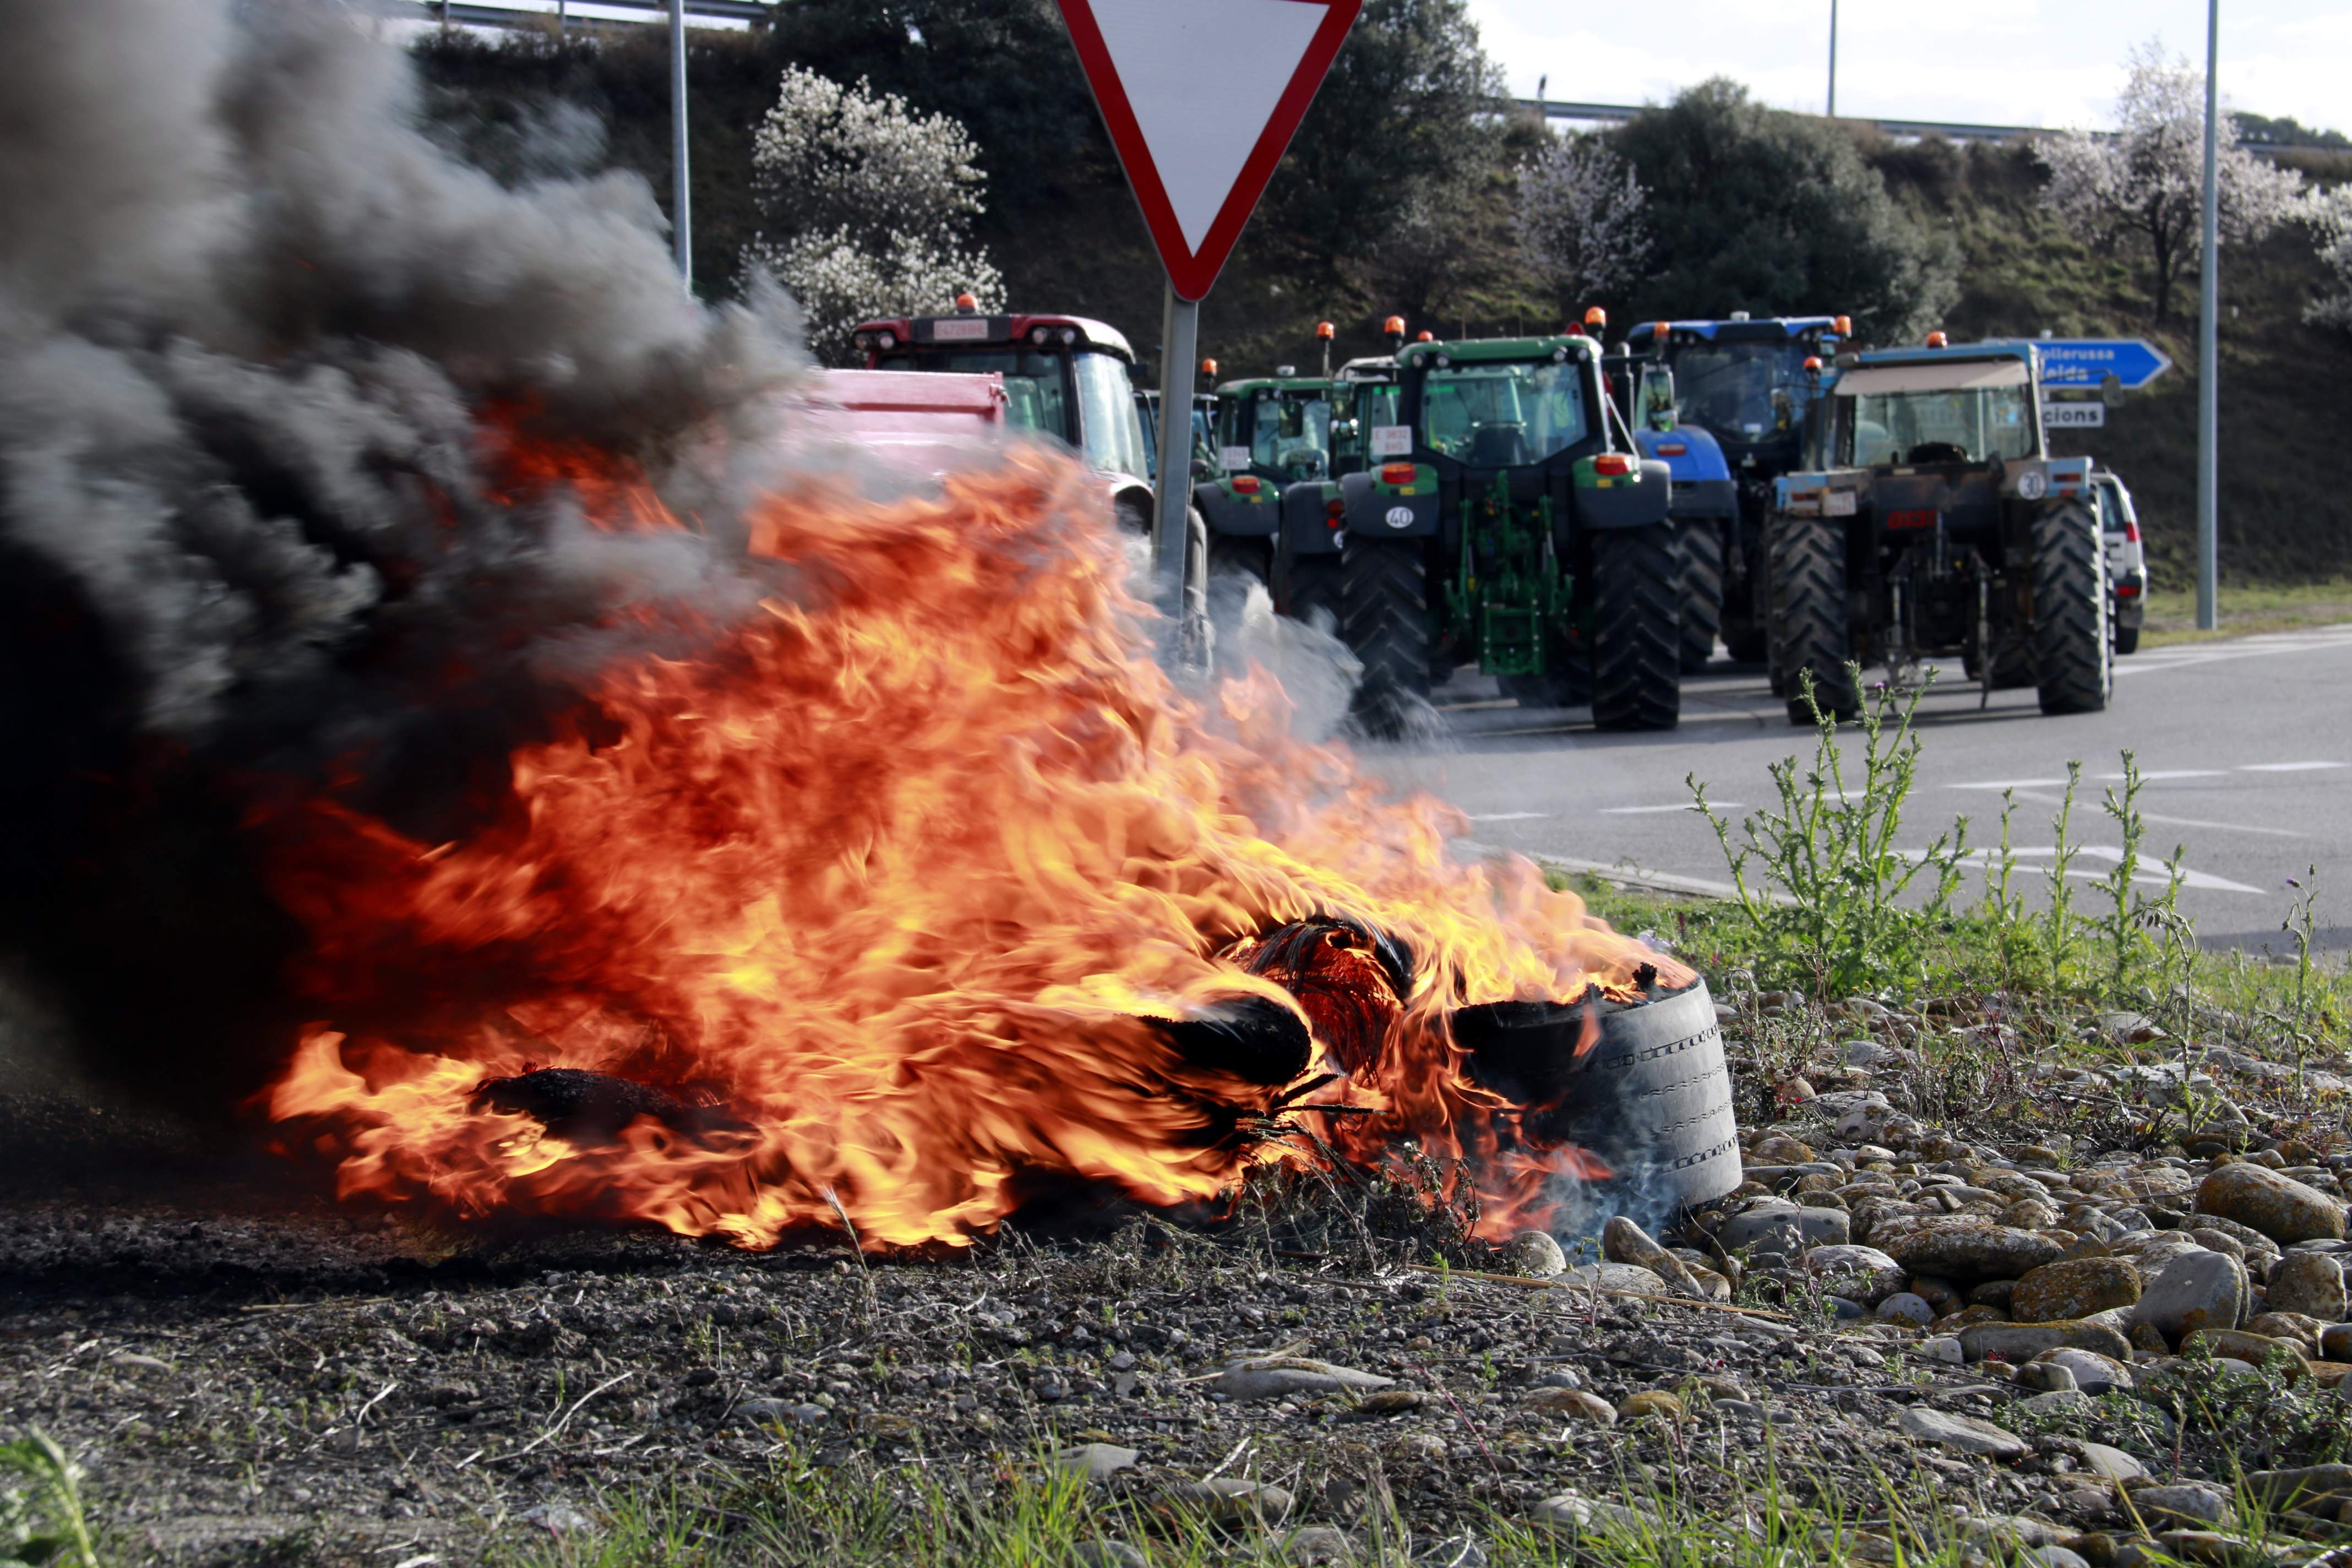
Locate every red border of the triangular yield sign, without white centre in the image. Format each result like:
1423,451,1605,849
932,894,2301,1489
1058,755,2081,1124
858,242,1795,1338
1058,0,1364,298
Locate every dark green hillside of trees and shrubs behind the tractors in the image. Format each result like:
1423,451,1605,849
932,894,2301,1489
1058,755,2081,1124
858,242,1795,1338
416,17,2352,583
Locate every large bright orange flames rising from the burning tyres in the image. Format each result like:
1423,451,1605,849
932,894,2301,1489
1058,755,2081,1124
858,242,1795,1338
268,451,1686,1246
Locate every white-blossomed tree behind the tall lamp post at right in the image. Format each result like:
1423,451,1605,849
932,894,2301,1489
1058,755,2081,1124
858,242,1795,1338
2039,40,2302,322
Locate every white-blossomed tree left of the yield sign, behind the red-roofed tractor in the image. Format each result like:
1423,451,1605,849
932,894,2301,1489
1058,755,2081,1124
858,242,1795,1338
743,66,1004,362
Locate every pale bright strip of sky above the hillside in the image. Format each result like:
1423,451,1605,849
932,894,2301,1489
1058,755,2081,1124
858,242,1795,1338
1470,0,2352,134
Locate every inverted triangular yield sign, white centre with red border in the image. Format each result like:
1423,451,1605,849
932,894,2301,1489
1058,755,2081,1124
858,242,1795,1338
1061,0,1364,298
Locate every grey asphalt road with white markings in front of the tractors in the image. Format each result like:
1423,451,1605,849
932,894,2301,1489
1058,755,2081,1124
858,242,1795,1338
1376,625,2352,950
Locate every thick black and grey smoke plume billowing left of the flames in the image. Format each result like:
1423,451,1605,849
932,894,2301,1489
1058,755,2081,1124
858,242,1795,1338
0,0,799,1105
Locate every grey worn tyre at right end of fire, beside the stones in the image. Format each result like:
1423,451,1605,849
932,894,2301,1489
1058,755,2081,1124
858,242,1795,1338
1453,981,1740,1211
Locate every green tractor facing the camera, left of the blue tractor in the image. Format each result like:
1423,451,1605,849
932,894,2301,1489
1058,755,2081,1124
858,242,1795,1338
1336,336,1681,729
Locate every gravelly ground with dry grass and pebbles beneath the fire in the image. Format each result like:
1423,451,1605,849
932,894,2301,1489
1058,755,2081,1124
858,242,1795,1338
14,997,2352,1568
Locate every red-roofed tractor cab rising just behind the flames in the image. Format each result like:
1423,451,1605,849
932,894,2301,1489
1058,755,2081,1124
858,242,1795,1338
851,294,1152,529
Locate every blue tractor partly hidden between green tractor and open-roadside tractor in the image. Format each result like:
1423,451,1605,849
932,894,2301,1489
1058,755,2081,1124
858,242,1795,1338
1620,311,1853,668
